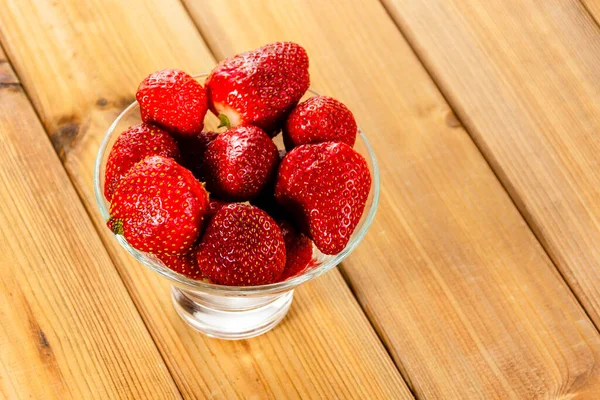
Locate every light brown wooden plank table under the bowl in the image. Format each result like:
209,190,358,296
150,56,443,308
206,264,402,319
0,0,600,399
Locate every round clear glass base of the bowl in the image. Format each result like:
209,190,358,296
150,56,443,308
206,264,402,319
171,286,294,340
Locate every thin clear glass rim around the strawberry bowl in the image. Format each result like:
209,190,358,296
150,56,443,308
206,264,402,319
94,73,380,295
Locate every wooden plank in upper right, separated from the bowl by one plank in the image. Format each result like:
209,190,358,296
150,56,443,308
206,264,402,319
386,0,600,326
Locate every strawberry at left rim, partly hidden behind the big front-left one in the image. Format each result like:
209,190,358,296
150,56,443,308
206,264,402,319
104,123,179,201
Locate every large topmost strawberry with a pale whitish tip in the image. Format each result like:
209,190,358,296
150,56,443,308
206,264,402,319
206,42,310,133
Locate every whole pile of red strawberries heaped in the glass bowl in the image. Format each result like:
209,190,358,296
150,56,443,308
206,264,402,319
104,43,371,286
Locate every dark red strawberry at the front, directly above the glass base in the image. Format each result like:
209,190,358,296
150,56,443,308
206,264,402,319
198,203,285,286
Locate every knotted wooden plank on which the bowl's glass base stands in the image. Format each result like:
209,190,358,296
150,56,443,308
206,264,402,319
0,0,412,399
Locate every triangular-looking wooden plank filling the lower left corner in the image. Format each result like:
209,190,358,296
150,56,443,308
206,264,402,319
0,49,180,399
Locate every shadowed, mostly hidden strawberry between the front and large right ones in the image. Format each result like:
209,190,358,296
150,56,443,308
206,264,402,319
279,221,313,281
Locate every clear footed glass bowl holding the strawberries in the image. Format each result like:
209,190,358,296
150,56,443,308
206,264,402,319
94,74,379,339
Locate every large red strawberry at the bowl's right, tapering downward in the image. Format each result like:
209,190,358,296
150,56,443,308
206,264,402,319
275,142,371,254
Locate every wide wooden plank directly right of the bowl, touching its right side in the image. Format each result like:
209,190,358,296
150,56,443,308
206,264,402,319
186,0,600,399
